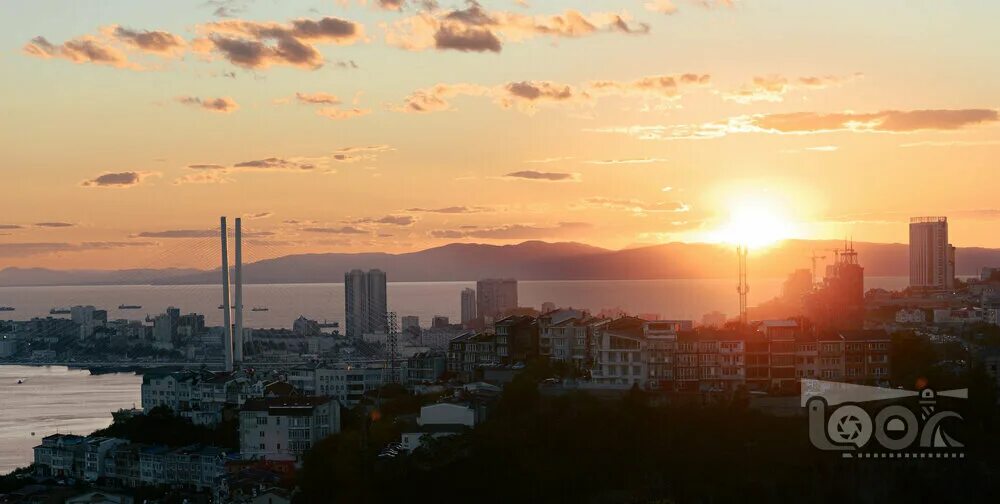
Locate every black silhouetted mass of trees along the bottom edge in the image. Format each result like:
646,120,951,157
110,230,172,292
297,366,1000,503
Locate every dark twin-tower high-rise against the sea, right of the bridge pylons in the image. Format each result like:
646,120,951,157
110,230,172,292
344,269,388,338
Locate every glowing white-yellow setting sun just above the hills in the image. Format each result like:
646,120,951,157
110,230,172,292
712,197,796,249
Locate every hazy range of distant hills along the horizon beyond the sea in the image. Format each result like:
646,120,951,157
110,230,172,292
0,240,1000,286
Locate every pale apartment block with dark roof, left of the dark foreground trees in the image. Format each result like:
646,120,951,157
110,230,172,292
240,396,340,460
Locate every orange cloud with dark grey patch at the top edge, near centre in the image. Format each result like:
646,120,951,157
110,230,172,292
383,0,649,53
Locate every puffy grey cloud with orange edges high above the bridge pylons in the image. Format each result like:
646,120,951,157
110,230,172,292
194,17,364,70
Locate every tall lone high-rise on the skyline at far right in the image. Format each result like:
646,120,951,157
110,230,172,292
910,217,955,289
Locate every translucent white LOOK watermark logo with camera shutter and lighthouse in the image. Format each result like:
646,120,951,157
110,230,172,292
801,380,969,458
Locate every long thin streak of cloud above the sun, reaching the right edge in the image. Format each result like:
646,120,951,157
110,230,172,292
584,109,1000,140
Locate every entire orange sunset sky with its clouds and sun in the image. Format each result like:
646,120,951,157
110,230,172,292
0,0,1000,268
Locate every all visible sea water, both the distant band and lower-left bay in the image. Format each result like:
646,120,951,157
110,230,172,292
0,277,908,474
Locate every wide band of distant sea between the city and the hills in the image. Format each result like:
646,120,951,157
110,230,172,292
0,277,907,328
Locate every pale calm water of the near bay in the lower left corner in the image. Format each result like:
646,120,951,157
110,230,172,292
0,366,142,474
